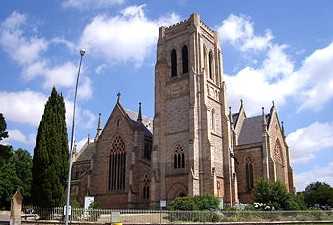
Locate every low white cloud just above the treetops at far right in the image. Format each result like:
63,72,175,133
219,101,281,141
295,162,333,191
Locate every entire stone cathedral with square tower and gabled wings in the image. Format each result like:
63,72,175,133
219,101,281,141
72,14,294,208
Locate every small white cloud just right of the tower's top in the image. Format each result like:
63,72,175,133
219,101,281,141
217,14,273,51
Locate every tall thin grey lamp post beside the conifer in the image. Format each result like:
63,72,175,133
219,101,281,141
65,49,86,225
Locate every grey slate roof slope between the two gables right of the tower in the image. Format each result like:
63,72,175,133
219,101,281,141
238,116,263,145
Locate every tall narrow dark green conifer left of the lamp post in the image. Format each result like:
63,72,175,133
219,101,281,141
31,87,69,208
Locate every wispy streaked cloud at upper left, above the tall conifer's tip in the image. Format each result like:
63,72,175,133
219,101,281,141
0,11,92,98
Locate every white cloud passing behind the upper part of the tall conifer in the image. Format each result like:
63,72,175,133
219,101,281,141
0,90,97,128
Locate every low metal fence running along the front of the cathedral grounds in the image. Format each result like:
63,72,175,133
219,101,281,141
23,208,333,224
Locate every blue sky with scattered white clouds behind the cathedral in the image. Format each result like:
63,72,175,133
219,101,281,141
0,0,333,190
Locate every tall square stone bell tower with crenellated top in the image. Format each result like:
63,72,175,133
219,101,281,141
151,14,237,206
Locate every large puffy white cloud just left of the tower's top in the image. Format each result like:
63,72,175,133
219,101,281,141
80,5,179,66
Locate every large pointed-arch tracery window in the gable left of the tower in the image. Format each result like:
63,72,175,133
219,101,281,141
109,136,126,191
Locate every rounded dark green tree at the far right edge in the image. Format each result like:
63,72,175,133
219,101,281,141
304,182,333,207
